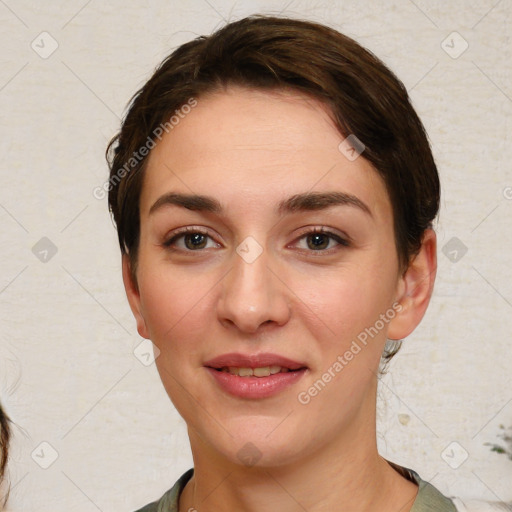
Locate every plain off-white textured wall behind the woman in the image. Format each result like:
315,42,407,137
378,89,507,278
0,0,512,512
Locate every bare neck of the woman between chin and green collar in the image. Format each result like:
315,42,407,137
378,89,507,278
179,402,418,512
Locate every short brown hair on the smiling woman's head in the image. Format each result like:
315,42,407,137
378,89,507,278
107,15,440,276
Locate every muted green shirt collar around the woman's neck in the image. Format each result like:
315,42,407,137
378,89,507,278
136,464,456,512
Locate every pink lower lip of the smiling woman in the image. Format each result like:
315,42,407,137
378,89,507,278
206,367,306,399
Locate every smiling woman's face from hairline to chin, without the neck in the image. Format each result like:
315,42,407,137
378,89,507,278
125,87,408,465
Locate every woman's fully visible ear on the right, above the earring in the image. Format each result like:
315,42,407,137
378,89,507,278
388,229,437,340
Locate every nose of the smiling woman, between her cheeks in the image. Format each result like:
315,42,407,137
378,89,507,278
217,246,291,334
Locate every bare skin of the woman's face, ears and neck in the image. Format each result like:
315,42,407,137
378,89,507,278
123,87,436,512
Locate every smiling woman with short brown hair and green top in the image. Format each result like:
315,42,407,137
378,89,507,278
105,16,455,512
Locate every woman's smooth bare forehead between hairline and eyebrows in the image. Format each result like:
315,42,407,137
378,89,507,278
141,87,391,220
